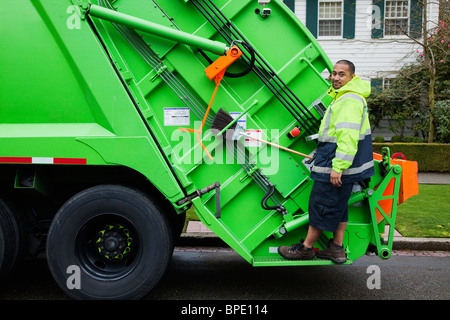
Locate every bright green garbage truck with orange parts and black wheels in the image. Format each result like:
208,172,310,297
0,0,417,299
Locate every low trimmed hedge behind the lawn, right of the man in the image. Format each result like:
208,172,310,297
373,143,450,172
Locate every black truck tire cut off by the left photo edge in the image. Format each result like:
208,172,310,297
0,198,22,280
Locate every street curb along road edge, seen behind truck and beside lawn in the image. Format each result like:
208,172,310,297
175,232,450,251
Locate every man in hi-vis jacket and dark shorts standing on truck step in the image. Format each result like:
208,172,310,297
278,60,374,263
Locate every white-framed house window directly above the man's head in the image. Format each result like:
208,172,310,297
318,1,343,37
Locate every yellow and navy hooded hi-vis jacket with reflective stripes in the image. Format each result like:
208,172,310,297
311,76,374,183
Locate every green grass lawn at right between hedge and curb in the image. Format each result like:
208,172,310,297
395,184,450,238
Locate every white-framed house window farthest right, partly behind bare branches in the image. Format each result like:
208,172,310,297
384,1,409,36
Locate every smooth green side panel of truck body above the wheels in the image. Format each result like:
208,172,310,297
0,0,183,201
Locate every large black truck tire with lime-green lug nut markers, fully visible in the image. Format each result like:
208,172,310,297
47,185,173,299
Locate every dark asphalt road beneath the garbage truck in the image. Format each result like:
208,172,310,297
0,248,450,301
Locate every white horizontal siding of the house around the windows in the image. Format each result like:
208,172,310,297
295,0,438,79
